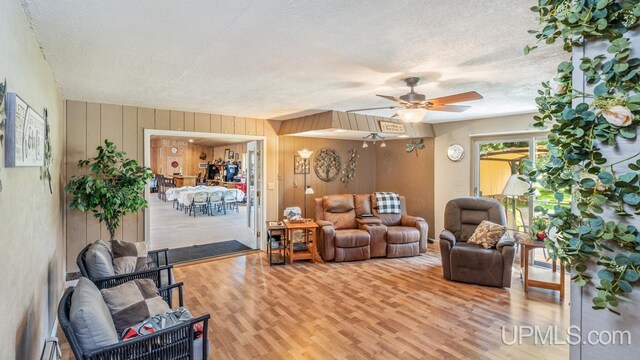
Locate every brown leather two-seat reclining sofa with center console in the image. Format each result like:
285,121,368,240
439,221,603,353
315,194,428,262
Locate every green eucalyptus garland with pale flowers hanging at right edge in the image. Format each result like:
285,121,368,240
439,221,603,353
525,0,640,314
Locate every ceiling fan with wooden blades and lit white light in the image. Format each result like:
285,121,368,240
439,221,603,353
347,77,482,122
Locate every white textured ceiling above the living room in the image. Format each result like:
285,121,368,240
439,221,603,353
20,0,562,122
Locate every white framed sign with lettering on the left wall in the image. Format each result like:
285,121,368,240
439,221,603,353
5,93,45,167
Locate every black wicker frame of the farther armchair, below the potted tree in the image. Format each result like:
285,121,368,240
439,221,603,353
76,245,173,289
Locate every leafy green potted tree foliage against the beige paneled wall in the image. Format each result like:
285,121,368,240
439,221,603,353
65,140,152,240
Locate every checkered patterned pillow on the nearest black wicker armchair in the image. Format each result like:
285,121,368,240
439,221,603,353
100,279,171,334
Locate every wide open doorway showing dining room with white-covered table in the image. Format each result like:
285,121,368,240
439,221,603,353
144,129,265,262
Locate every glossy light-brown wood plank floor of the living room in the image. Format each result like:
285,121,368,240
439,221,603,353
175,245,569,360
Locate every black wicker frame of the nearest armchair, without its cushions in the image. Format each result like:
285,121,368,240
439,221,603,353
58,283,210,360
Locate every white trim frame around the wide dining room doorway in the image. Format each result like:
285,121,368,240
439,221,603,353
143,129,267,250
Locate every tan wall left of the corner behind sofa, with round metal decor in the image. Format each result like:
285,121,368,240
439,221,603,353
278,136,376,219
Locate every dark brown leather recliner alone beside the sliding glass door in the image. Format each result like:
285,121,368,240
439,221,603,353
440,197,514,287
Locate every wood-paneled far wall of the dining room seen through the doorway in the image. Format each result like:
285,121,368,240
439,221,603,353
150,138,247,176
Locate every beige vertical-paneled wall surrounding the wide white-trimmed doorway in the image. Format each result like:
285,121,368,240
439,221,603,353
66,100,280,272
